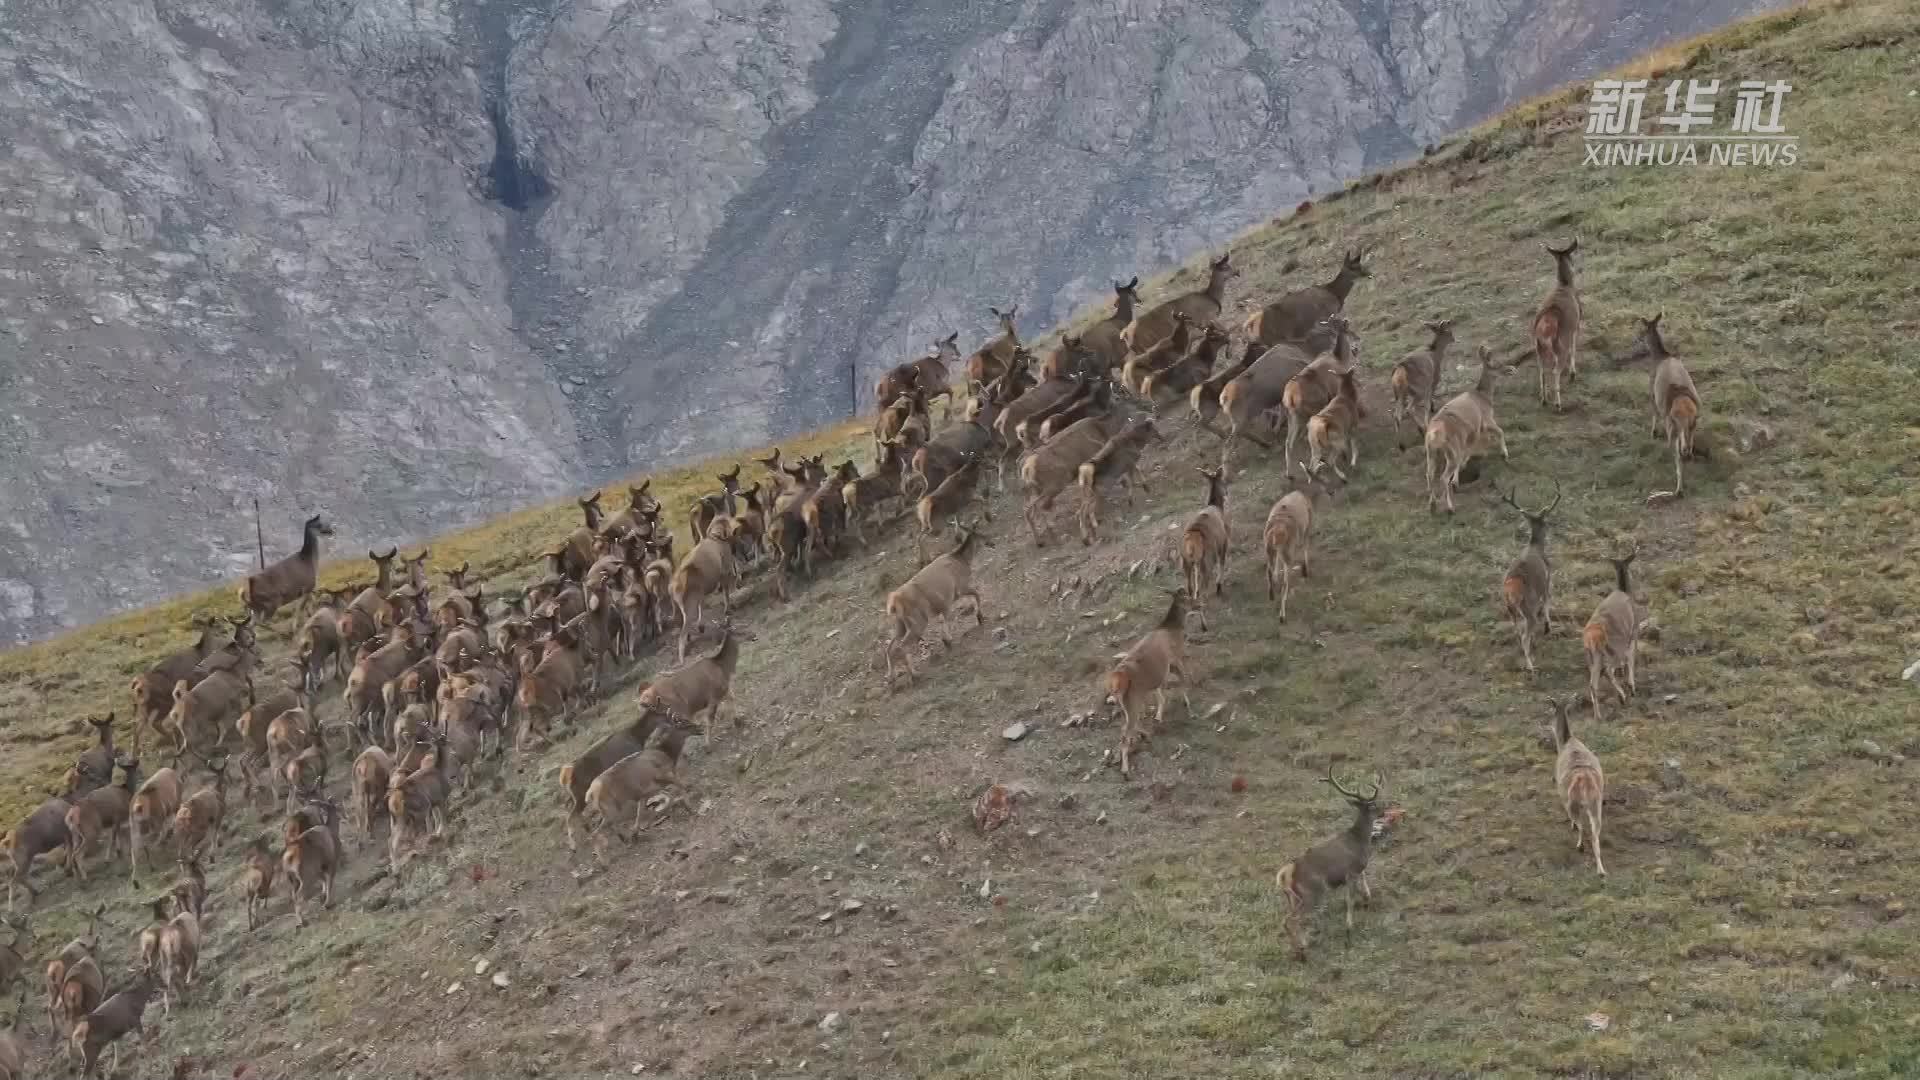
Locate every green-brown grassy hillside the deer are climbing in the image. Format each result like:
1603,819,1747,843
0,2,1920,1078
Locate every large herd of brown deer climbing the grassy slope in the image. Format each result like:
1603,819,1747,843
0,242,1699,1080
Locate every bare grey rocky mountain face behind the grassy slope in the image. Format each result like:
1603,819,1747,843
0,0,1770,640
